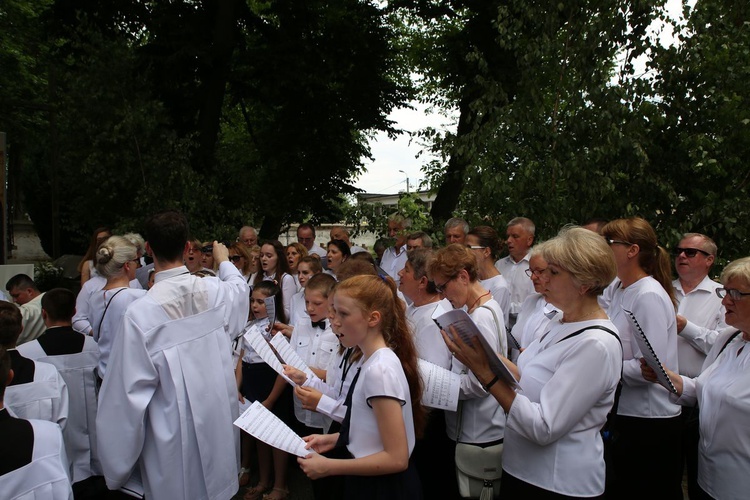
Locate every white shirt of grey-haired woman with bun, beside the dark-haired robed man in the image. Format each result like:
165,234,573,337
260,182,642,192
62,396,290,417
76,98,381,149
87,288,146,379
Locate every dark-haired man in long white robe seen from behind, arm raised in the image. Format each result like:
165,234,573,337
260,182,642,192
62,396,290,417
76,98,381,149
97,211,249,499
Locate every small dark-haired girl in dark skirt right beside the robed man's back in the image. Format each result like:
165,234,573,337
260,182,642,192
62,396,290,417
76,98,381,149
235,281,294,500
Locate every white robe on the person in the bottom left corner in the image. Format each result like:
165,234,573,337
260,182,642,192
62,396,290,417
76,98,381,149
0,420,73,500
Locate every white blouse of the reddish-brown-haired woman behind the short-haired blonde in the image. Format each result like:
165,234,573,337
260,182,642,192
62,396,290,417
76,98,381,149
608,276,680,418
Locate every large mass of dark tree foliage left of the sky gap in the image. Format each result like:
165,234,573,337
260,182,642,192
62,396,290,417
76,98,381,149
0,0,409,253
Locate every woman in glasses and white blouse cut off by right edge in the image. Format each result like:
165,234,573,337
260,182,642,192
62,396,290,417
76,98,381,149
641,257,750,500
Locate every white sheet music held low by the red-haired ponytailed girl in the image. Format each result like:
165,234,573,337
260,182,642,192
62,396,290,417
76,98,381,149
234,401,312,457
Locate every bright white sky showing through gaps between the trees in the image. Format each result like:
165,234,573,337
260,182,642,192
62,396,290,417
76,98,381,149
354,0,695,194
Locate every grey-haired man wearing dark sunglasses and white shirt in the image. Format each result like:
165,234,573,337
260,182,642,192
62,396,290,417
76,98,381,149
672,233,726,498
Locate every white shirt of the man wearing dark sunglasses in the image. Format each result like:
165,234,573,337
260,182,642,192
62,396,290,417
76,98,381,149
672,276,727,377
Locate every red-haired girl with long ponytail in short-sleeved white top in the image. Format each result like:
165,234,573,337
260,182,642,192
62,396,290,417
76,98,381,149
298,276,424,500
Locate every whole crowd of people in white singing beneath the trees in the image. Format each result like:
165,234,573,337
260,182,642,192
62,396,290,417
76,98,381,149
0,211,750,500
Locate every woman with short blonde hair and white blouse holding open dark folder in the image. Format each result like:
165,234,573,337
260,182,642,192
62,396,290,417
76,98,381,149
443,228,622,499
